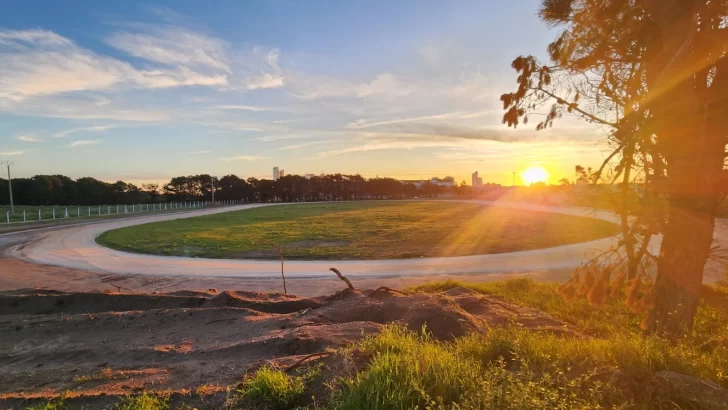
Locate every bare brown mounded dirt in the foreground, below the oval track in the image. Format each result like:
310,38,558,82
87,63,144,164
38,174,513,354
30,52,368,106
0,288,573,408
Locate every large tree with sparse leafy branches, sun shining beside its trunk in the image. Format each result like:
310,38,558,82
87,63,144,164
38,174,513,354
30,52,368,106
502,0,728,335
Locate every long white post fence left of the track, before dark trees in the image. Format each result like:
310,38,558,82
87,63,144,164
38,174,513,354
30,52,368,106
0,200,243,224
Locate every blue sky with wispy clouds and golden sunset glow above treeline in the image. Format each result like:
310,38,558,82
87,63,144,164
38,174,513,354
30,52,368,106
0,0,606,184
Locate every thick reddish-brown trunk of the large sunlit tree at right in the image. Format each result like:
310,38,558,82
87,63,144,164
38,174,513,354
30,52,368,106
646,0,726,337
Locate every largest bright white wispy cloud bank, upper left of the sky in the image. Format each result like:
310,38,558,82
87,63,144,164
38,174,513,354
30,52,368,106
0,28,229,101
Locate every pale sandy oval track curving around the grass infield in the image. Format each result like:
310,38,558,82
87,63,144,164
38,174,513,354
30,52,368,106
0,201,728,282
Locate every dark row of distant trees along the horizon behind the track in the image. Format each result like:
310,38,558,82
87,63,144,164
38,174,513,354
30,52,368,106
0,174,506,205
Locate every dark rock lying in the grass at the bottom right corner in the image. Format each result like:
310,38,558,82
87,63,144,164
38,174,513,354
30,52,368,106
654,370,728,409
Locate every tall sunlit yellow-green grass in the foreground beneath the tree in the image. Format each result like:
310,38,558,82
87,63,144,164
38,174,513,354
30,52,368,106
331,326,728,409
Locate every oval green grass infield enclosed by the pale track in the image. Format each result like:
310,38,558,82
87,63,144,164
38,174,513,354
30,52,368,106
97,201,618,260
